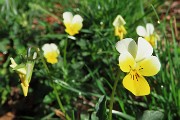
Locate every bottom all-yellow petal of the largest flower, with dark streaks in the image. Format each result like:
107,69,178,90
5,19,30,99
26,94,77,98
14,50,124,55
123,73,150,96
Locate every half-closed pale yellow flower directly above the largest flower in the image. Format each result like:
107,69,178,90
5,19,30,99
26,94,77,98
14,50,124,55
113,15,127,39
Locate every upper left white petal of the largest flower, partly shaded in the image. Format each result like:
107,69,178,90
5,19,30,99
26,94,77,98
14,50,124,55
116,38,137,58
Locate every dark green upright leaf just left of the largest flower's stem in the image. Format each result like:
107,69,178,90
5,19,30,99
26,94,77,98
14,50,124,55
95,95,107,120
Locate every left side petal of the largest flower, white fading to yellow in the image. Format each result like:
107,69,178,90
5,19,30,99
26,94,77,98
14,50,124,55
119,52,136,72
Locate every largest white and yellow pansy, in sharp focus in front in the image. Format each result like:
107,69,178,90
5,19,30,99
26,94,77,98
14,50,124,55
116,37,161,96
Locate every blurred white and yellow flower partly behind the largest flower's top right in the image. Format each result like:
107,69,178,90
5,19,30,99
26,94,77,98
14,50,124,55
136,23,159,47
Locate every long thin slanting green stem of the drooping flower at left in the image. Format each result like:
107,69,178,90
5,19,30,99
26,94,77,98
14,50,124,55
38,52,71,120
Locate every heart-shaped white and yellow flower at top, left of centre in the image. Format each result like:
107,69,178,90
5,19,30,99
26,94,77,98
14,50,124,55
63,12,83,36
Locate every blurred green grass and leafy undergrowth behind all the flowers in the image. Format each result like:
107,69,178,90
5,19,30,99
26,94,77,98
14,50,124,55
0,0,180,120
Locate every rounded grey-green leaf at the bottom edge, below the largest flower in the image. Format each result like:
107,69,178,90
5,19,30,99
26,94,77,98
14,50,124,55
141,110,164,120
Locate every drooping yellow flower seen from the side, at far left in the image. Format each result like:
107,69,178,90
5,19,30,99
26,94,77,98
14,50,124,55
10,58,34,96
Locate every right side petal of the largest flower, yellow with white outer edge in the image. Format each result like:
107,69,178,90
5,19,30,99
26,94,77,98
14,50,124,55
138,56,161,76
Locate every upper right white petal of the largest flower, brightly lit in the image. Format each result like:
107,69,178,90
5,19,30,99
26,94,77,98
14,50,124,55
135,37,153,62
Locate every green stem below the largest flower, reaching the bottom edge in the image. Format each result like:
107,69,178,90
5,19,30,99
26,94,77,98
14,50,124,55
109,78,119,120
